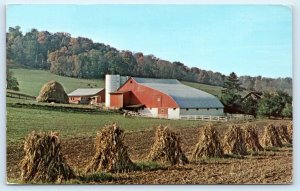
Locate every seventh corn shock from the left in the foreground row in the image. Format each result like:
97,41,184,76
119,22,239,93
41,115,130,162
262,123,283,147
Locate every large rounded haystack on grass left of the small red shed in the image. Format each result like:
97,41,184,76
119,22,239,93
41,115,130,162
36,80,69,103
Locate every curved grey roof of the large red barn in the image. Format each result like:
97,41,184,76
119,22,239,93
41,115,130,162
132,77,224,108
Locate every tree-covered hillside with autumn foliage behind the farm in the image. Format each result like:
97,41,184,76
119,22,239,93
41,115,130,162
6,26,292,94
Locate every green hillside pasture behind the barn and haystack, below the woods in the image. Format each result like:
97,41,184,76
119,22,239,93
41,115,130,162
11,69,222,96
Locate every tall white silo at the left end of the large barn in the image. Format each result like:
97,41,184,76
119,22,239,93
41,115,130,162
105,74,121,107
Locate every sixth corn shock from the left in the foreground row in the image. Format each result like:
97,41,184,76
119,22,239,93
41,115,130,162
244,125,264,152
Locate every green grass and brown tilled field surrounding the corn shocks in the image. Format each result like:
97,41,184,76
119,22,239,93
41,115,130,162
7,98,292,184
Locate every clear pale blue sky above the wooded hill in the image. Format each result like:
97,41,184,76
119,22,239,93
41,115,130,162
6,4,292,78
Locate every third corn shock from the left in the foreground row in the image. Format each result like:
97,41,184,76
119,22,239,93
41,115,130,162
148,126,188,165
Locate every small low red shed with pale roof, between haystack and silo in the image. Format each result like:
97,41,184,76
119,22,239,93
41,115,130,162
68,88,105,104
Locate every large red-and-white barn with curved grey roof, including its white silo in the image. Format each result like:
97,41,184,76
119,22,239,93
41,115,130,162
105,75,224,119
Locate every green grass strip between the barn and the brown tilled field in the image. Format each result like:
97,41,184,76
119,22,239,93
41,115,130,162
6,98,204,145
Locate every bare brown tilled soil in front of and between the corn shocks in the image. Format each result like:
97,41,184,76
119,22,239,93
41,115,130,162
7,121,292,184
